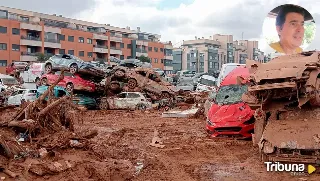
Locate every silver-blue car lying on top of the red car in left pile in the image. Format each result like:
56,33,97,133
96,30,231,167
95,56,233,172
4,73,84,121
45,54,105,77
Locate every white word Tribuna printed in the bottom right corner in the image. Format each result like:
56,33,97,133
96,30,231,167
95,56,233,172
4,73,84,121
264,162,305,172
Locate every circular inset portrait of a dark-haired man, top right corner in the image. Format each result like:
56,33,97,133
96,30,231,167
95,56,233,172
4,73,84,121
262,4,316,54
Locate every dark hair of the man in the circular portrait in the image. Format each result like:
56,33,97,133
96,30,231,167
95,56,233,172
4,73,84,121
276,4,305,28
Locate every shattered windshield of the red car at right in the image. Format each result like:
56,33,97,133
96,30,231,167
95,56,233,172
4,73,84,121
215,85,248,105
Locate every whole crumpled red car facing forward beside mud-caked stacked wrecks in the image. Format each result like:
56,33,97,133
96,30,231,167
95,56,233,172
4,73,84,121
206,67,254,138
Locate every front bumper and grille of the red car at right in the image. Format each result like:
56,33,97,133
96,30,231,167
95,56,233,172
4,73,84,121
206,121,254,138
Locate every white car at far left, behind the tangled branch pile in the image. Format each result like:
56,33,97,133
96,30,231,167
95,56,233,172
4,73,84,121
8,89,37,106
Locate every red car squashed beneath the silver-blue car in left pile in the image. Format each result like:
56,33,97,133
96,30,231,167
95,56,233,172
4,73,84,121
41,71,96,92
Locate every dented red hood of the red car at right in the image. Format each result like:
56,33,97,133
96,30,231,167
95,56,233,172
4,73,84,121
208,102,254,123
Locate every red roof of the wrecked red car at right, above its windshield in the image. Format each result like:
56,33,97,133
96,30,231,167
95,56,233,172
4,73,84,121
220,66,249,86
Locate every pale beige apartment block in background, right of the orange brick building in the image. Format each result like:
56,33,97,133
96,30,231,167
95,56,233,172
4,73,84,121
173,34,263,73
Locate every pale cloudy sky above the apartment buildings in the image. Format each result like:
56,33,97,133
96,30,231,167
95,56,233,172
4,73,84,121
0,0,320,51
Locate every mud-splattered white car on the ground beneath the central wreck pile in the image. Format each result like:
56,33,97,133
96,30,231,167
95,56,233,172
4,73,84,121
99,92,152,110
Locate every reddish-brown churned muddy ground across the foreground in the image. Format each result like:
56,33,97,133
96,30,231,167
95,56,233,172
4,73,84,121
0,110,320,181
